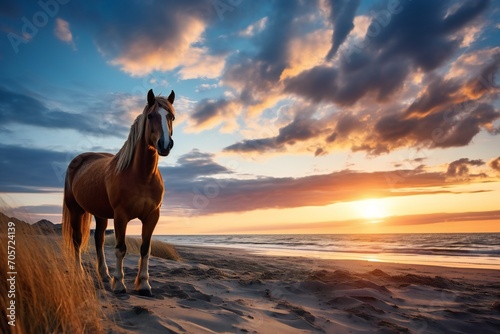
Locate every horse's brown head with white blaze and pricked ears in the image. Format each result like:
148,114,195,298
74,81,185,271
145,89,175,156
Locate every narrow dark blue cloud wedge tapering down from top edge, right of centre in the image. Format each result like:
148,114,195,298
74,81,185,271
326,0,360,60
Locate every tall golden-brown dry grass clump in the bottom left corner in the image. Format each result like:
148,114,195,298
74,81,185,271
0,215,102,333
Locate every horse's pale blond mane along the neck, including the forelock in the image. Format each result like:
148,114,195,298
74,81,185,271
113,96,175,172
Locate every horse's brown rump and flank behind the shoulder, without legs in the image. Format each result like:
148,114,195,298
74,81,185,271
65,152,113,218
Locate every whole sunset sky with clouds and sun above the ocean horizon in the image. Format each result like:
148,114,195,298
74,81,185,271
0,0,500,235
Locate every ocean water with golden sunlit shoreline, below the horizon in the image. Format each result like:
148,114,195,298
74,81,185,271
154,233,500,270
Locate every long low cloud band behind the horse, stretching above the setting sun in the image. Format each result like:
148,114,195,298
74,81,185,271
0,145,494,215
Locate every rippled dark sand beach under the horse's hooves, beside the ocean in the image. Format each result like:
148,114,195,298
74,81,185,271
94,246,500,333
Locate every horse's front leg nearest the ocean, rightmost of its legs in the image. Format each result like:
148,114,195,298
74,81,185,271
135,209,160,297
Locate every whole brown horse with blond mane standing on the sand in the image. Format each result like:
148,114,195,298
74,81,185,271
62,90,175,296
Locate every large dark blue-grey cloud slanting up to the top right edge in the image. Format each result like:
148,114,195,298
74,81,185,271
285,0,490,105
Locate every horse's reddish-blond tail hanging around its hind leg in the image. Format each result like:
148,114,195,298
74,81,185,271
62,177,92,254
